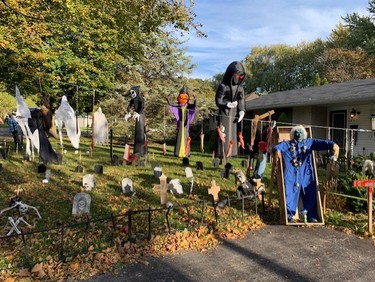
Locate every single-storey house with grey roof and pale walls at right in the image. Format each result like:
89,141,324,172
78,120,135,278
246,78,375,156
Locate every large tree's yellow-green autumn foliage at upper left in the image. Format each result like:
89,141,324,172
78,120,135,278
0,0,203,109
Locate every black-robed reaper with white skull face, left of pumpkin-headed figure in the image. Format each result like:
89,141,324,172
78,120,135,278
125,86,147,156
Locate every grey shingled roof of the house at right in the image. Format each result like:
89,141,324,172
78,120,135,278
246,78,375,110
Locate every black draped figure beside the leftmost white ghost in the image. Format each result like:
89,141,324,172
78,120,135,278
28,98,58,164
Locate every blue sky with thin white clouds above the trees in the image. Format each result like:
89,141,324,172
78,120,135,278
185,0,369,79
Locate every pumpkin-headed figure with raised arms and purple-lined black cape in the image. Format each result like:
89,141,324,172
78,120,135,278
166,85,196,158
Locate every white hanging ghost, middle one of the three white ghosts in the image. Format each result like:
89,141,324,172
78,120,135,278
55,95,81,149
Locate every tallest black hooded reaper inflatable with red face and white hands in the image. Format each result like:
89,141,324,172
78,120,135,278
215,61,246,159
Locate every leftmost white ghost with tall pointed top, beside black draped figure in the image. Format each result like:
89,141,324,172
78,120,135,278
15,86,39,156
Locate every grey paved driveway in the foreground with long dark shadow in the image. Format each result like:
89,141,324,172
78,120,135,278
87,225,375,282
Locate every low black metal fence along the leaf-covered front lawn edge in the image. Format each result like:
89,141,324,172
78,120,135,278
0,194,264,267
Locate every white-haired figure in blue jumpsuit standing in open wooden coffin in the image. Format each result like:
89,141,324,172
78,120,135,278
272,126,339,222
